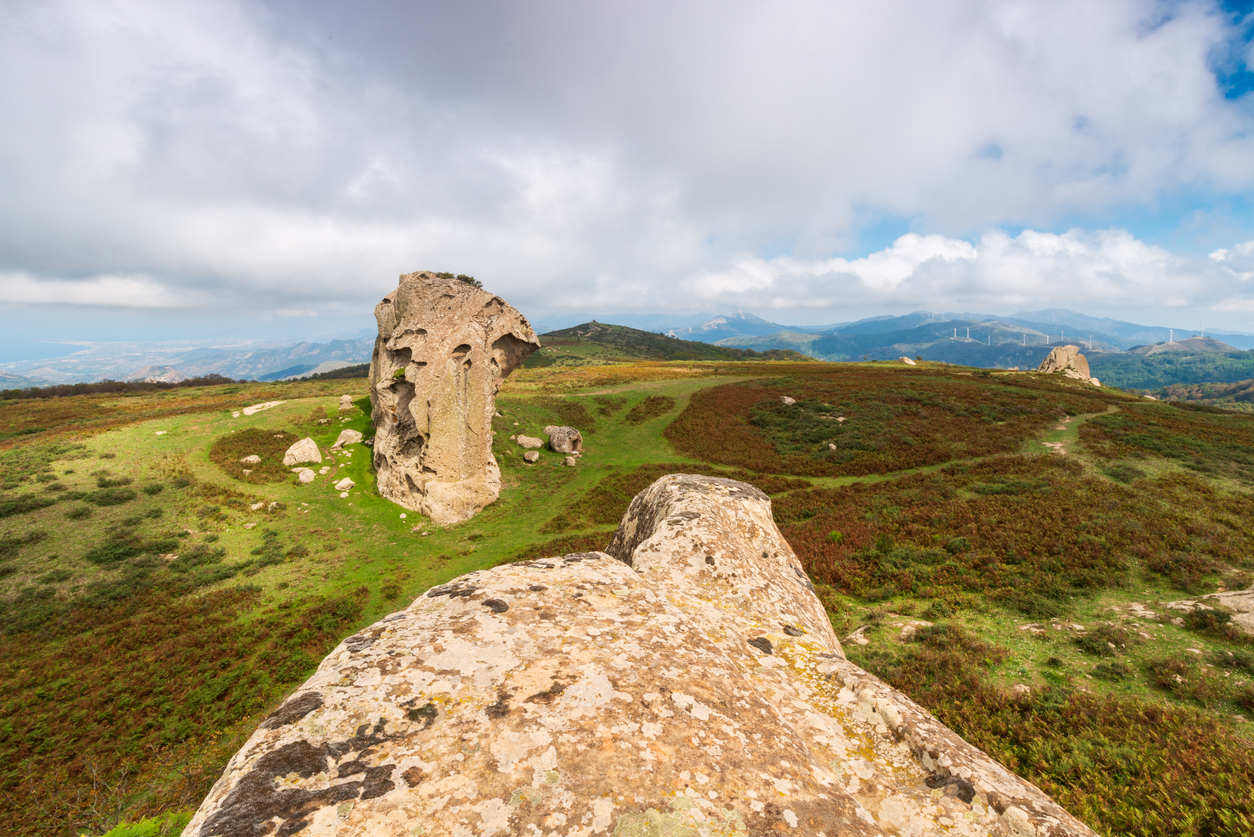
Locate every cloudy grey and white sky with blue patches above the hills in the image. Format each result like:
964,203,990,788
0,0,1254,340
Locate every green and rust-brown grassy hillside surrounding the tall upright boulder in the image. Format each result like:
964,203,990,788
0,366,1254,837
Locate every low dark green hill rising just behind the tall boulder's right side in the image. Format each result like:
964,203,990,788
525,320,809,369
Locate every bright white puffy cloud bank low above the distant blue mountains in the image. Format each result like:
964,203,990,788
686,230,1254,311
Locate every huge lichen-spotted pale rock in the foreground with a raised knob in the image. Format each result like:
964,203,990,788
183,474,1093,837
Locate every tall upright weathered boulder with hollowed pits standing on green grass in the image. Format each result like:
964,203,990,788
370,272,539,525
